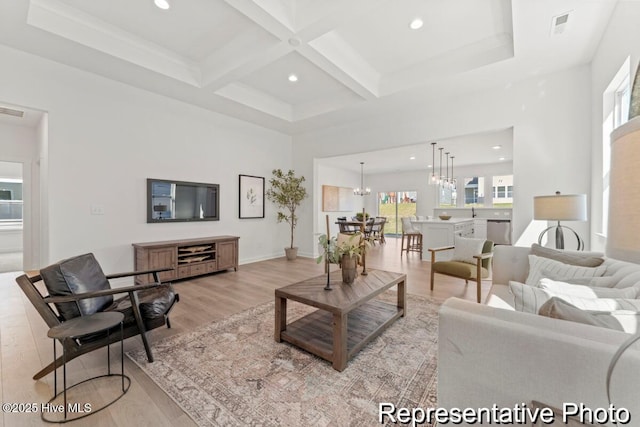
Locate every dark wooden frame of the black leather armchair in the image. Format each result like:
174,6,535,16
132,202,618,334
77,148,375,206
16,268,179,380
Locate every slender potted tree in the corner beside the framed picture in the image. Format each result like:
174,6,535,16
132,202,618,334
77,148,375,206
266,169,307,260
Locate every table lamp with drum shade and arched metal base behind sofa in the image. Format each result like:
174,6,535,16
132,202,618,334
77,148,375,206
533,191,587,251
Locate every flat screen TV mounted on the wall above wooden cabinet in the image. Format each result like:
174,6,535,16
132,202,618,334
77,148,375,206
147,178,220,223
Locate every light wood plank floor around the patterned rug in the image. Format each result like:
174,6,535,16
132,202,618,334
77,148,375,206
0,238,490,427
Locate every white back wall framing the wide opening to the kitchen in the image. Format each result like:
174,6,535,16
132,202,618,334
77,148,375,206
293,66,591,254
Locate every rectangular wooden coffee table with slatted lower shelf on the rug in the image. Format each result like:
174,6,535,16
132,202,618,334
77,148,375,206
275,270,407,371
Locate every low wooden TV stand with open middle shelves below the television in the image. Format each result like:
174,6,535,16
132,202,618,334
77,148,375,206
132,236,239,284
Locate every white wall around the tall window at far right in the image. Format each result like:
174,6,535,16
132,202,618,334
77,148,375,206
591,1,640,251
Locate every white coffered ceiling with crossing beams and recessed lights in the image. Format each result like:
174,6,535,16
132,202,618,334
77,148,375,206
0,0,628,138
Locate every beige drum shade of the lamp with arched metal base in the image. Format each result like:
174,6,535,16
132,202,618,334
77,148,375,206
533,194,587,221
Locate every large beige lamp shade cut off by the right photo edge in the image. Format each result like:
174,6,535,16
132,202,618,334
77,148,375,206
606,116,640,263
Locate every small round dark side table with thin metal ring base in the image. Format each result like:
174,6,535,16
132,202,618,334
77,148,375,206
41,311,131,423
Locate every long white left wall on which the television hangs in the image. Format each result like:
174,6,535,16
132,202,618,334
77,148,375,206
0,46,292,272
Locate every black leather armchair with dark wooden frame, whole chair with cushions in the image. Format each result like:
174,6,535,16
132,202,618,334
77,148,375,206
16,253,179,380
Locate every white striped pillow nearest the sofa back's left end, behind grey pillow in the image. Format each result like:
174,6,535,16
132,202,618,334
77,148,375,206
509,281,640,313
